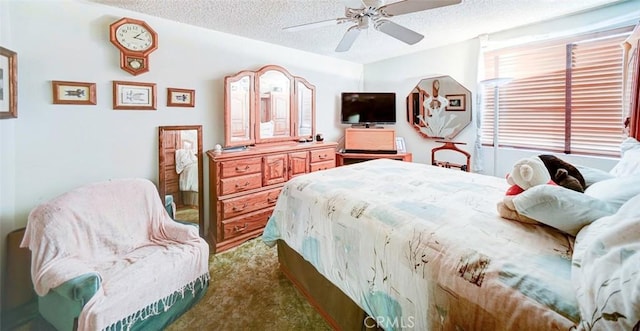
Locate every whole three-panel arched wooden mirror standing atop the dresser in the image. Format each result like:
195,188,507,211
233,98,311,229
224,65,315,147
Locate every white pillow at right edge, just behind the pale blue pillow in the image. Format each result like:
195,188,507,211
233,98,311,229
584,176,640,210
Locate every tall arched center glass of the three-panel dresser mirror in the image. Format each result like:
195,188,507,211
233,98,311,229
259,70,292,139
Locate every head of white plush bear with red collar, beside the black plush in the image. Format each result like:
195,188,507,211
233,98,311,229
506,157,555,196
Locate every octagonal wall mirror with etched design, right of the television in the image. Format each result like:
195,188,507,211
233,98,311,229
407,76,473,139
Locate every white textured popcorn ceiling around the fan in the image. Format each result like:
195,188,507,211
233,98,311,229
89,0,618,63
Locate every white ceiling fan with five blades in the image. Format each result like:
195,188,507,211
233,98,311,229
284,0,462,52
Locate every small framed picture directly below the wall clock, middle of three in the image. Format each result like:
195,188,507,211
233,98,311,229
113,80,156,110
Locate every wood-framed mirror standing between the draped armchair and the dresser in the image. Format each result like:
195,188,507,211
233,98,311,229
158,125,204,238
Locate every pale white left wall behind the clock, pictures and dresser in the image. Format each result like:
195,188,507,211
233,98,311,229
0,0,363,320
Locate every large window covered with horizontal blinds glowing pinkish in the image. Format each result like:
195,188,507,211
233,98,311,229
481,27,632,156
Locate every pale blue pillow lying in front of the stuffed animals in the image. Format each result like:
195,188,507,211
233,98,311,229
513,184,618,236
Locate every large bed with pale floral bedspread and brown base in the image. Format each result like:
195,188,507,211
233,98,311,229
263,159,640,330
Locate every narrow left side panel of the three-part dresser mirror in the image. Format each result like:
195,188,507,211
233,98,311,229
224,71,255,147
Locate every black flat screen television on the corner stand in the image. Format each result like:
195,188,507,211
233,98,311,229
340,92,396,126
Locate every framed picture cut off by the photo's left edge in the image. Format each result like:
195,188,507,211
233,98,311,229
0,46,18,118
